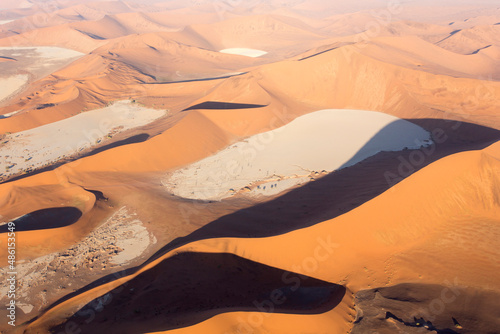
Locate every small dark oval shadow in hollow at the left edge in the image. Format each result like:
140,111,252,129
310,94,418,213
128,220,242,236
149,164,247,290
0,207,82,233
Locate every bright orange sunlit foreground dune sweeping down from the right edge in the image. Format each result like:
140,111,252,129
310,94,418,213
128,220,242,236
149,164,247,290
21,142,500,333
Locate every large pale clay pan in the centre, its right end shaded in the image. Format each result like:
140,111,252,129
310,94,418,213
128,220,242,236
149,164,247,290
163,110,431,200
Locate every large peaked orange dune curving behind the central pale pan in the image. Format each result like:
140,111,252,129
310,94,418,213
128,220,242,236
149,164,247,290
6,40,500,176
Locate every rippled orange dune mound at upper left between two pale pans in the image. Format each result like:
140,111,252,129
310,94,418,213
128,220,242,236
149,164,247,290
0,55,156,132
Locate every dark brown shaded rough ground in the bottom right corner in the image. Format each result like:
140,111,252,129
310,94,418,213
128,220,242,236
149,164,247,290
351,282,500,334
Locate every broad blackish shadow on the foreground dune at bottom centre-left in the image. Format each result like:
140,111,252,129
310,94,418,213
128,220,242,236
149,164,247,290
51,253,346,334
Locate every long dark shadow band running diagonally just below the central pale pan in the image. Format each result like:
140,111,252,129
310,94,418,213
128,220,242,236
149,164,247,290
22,119,500,330
